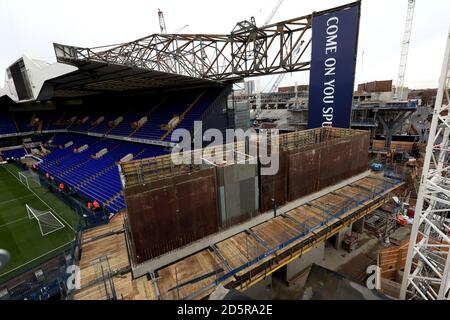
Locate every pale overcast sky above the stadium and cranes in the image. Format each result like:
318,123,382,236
0,0,450,88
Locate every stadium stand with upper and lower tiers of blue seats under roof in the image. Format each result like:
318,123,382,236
0,87,229,214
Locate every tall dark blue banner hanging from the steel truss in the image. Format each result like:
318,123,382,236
308,2,360,128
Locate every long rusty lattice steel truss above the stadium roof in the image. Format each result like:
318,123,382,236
54,15,312,81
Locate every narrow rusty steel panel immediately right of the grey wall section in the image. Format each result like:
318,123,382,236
260,151,289,212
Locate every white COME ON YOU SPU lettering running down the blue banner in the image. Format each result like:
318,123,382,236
322,17,339,127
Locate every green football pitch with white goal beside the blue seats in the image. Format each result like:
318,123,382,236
0,164,79,283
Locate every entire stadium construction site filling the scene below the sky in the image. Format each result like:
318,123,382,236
0,0,450,300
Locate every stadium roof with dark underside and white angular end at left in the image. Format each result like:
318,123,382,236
0,55,220,104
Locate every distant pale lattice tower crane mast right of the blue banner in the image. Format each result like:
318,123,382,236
395,0,416,99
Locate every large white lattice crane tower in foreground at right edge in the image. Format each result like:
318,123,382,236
400,30,450,300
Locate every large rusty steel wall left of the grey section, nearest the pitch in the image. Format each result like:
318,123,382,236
125,169,218,263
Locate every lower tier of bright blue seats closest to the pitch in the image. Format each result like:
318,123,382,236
38,134,167,213
